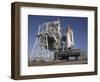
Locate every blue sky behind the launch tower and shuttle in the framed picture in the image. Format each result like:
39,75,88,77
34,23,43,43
28,15,88,55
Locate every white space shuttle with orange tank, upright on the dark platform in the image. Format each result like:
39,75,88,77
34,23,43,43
67,25,75,49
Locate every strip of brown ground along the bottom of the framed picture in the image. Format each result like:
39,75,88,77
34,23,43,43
28,60,87,66
